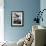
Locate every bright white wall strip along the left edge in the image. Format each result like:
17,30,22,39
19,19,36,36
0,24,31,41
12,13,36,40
0,0,4,42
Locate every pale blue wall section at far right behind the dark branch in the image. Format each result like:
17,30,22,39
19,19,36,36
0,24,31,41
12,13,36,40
40,0,46,27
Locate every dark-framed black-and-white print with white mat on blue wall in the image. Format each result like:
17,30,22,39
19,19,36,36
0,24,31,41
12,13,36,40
11,11,24,27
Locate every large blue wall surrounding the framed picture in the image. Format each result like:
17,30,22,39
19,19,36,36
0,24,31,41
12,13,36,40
4,0,40,41
